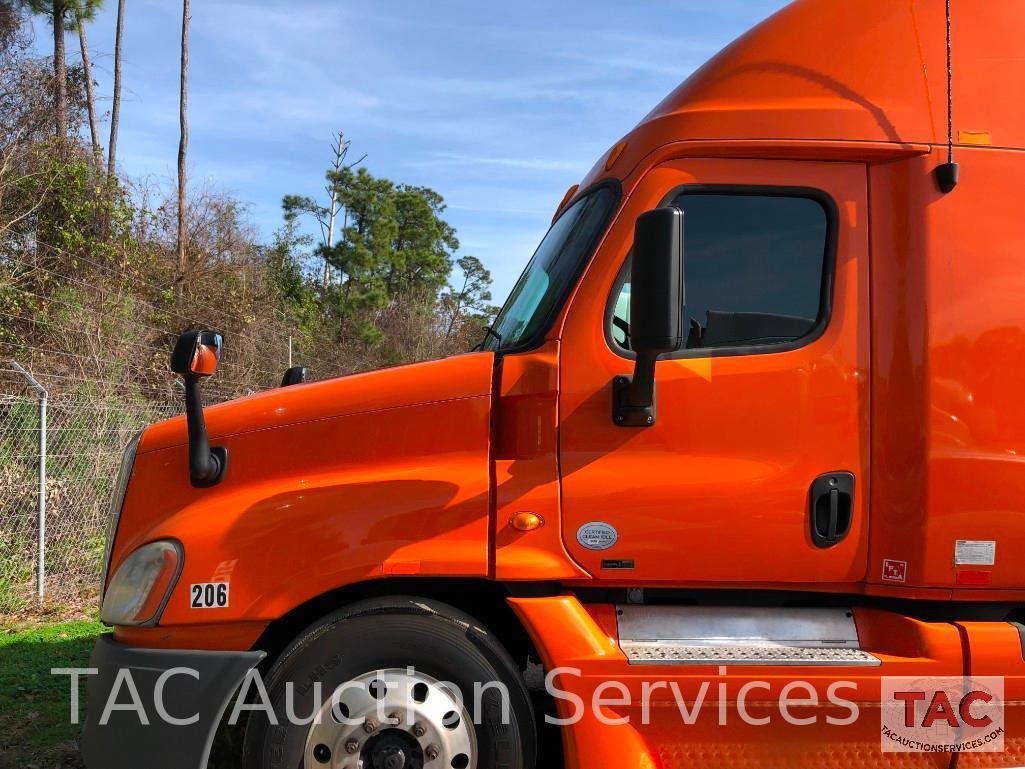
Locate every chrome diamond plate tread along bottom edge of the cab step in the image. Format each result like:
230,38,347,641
620,641,879,666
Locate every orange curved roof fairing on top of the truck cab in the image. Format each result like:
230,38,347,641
582,0,1025,187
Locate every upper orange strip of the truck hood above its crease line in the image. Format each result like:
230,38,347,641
138,353,494,454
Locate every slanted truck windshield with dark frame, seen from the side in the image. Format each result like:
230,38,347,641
482,187,617,350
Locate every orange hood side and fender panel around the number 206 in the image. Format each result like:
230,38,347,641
114,355,493,625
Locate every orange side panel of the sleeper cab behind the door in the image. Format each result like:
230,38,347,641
868,148,1025,602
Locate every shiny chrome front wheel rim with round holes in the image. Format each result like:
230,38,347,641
305,667,477,769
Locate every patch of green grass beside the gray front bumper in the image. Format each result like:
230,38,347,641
0,619,104,769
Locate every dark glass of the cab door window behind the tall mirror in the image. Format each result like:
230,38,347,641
611,191,829,352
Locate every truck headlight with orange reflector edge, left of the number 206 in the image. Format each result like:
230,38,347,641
99,539,183,624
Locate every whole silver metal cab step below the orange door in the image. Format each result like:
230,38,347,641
616,605,879,666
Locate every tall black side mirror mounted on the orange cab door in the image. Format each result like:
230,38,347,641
612,206,684,428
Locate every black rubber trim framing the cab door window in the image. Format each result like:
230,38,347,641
603,185,839,361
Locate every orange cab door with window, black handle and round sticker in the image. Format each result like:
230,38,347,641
560,159,870,583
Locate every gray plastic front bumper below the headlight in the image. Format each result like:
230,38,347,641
82,635,264,769
